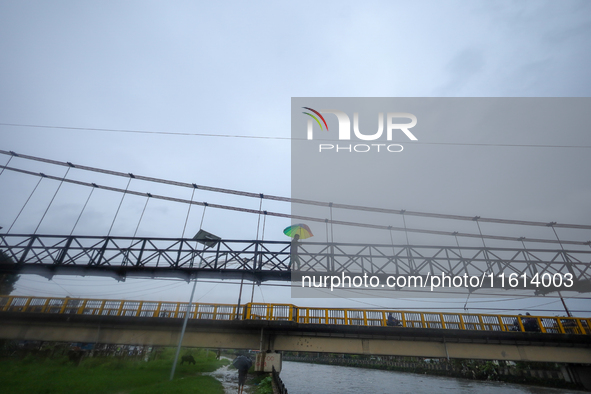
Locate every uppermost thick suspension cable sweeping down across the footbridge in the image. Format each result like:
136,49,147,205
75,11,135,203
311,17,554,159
0,150,591,230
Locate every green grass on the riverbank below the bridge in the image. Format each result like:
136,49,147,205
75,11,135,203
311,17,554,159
0,349,228,394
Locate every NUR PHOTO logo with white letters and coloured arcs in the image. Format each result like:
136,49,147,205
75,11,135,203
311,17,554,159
302,107,418,153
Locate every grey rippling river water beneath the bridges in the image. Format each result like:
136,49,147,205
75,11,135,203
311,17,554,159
281,361,582,394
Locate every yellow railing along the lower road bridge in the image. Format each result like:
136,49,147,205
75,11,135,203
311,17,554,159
0,296,591,335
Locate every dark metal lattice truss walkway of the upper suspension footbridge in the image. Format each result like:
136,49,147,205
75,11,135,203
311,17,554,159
0,234,591,292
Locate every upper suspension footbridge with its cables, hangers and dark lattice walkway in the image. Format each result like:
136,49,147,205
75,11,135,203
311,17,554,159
0,150,591,294
